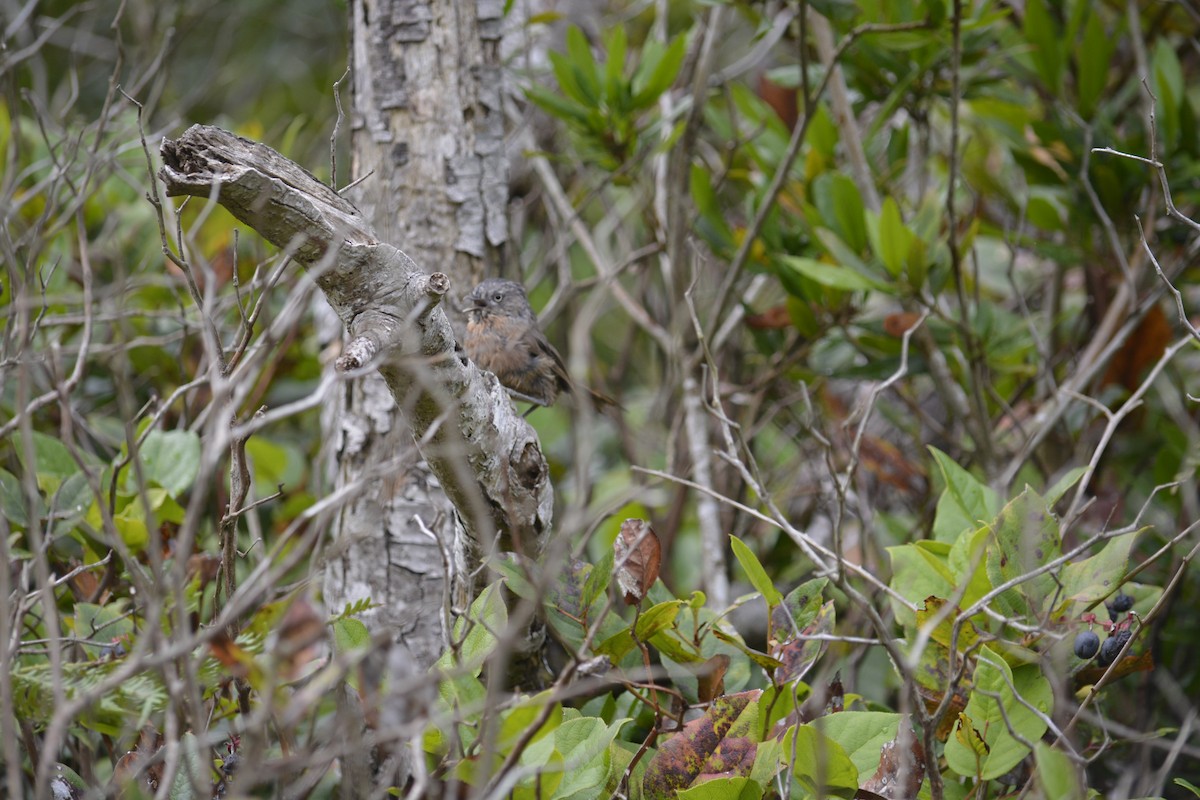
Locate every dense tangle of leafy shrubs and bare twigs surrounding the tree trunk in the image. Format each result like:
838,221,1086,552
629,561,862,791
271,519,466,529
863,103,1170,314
7,0,1200,798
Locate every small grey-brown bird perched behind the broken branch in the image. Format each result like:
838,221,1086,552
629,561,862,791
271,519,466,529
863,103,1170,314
463,278,616,409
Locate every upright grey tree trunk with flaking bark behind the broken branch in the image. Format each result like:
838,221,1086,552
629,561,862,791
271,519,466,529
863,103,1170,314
324,0,508,667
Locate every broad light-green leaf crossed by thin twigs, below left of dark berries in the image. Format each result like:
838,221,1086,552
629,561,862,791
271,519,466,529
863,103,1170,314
946,645,1054,781
